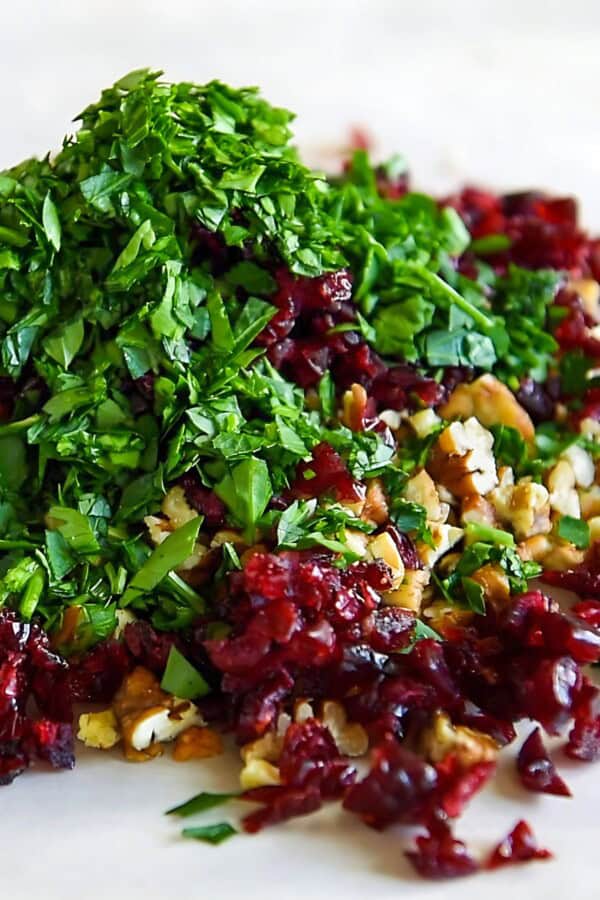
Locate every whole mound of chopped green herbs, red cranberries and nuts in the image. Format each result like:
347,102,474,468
0,71,600,877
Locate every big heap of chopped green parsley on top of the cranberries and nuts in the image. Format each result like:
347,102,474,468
0,71,572,650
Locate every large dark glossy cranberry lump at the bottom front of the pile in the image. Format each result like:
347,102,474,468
344,738,438,829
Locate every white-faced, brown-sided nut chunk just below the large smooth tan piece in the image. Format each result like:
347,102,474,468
429,418,498,497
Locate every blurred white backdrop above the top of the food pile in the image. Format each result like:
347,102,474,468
0,0,600,221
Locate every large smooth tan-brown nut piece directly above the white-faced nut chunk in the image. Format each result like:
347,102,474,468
438,375,535,442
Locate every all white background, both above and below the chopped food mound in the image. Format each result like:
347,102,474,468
0,7,600,900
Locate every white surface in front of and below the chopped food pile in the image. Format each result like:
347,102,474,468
0,704,600,900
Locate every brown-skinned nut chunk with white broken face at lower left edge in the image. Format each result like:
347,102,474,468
113,666,204,761
